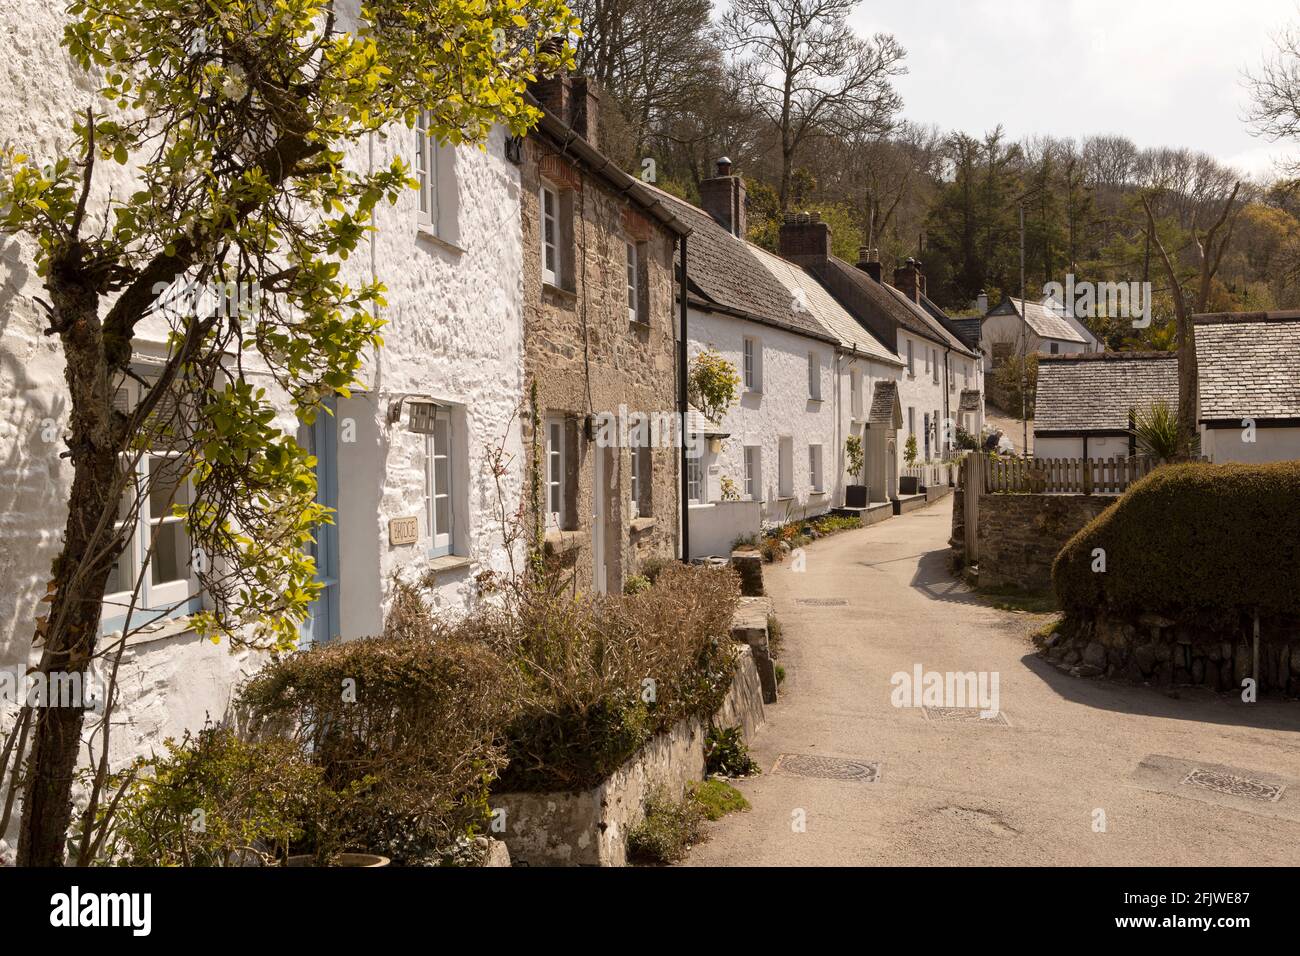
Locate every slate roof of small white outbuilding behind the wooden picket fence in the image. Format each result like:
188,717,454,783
1034,352,1178,434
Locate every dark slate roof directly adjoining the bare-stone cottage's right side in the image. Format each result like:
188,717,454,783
646,185,839,342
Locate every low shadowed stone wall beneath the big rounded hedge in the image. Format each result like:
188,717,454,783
1044,614,1300,696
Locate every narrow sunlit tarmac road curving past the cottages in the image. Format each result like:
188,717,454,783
688,498,1300,866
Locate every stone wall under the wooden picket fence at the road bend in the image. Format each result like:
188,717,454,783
972,493,1117,591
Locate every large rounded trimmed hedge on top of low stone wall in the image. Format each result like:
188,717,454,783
1052,462,1300,622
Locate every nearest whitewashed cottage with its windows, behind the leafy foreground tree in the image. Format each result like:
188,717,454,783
0,0,523,822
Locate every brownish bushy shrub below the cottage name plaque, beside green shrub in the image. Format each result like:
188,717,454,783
241,629,517,862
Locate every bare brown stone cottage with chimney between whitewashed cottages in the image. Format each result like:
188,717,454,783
520,75,689,593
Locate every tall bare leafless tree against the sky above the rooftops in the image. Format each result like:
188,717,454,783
722,0,906,212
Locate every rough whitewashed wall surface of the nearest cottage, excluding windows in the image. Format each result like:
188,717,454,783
0,0,523,836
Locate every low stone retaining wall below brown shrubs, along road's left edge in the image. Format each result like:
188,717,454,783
493,646,763,866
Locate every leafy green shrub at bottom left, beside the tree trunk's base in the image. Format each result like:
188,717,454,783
101,727,329,866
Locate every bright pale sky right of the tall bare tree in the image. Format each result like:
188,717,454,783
850,0,1300,176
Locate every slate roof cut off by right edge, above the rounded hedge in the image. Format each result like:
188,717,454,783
1193,312,1300,421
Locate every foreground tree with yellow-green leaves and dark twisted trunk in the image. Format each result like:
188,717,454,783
0,0,576,865
